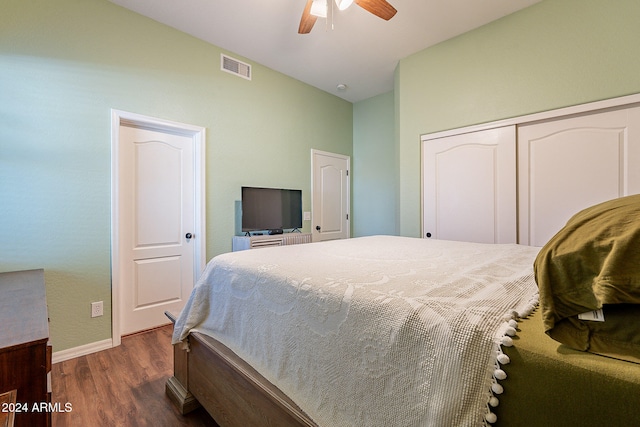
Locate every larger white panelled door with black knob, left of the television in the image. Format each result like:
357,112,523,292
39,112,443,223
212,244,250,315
113,111,204,344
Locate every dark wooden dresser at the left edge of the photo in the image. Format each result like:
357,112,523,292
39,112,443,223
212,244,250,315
0,270,51,427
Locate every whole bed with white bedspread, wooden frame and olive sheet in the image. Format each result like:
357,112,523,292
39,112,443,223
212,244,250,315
167,196,640,427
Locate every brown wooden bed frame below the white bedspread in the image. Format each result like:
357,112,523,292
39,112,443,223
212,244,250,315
165,313,317,427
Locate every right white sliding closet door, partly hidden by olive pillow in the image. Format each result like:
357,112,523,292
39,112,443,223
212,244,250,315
518,107,640,246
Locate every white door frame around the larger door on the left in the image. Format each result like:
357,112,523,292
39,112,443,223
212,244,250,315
111,109,206,347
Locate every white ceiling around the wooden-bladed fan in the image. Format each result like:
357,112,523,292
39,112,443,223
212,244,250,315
110,0,540,102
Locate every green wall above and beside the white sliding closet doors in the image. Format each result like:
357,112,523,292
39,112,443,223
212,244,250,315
395,0,640,236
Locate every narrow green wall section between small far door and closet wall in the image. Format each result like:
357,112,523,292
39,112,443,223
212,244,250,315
351,92,398,237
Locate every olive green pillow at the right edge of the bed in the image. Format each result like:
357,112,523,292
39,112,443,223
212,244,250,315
534,195,640,362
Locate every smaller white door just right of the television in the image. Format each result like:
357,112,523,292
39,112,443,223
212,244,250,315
311,150,350,242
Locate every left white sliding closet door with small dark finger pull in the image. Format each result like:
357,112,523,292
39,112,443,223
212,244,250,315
422,126,516,243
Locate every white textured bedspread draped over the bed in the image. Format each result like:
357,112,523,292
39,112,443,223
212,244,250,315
173,236,539,427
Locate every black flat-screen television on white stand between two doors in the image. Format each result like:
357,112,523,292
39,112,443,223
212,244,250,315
242,187,302,232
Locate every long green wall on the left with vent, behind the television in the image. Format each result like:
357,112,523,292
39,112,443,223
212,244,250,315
0,0,353,352
